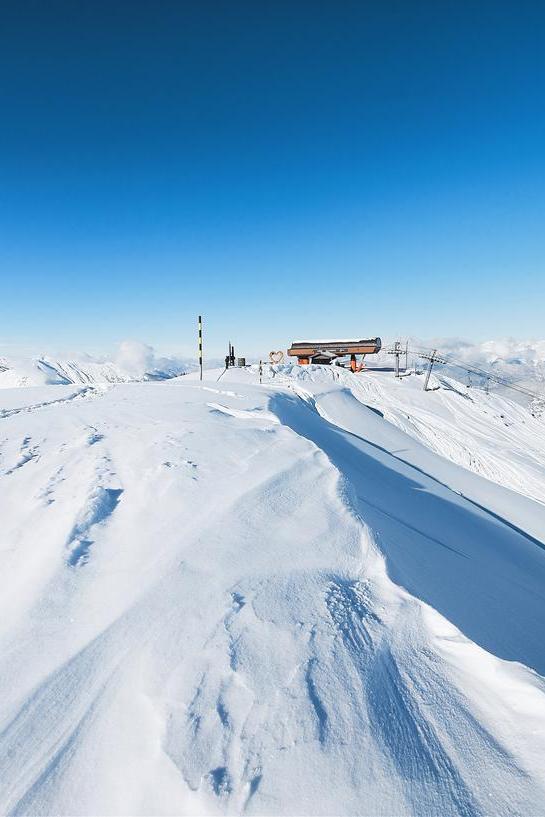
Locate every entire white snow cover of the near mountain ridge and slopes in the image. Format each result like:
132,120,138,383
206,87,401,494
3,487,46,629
0,364,545,815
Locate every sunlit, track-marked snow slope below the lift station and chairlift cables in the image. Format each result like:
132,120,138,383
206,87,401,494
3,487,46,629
273,365,545,502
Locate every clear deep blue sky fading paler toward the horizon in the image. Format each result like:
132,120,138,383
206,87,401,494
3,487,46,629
0,0,545,354
